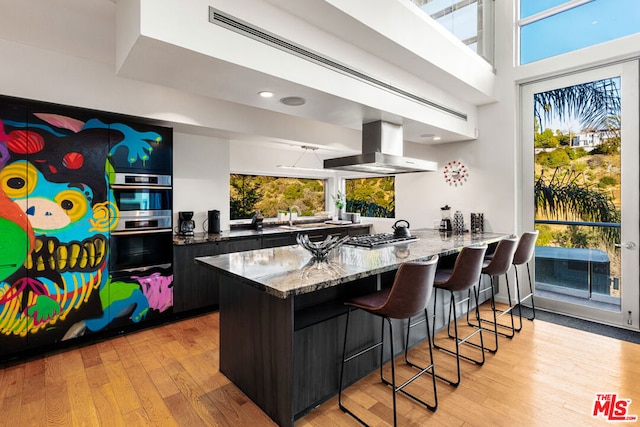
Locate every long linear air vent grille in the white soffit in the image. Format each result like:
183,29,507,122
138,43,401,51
209,6,467,121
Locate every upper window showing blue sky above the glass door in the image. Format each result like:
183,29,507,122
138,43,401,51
518,0,640,64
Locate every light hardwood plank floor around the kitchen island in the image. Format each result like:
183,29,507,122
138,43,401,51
0,313,640,427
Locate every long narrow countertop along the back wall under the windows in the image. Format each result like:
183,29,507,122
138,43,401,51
173,222,371,245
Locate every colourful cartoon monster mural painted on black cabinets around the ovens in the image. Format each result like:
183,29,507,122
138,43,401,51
0,99,173,353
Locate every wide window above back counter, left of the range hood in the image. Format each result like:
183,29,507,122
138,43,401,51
229,174,325,220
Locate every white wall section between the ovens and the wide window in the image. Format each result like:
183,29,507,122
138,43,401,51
173,132,229,232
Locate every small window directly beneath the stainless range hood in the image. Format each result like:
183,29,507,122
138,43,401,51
345,176,396,218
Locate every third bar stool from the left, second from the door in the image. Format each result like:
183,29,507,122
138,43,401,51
467,238,518,353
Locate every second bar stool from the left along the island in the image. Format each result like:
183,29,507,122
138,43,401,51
424,246,487,387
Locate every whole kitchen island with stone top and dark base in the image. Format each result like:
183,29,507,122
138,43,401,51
196,230,507,426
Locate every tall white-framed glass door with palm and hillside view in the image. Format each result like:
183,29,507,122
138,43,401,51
520,61,640,329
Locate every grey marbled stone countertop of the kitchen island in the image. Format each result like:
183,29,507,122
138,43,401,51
196,230,509,299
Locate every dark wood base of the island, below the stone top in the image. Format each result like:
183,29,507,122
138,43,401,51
220,274,426,426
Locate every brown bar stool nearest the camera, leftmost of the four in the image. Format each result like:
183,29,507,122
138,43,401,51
338,256,438,426
